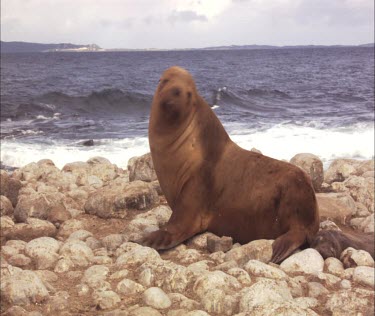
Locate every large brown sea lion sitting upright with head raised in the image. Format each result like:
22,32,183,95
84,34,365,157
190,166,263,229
139,67,319,263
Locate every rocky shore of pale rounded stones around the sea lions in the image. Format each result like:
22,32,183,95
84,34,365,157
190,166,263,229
0,154,374,316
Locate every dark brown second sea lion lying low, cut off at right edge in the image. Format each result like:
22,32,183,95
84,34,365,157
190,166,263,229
310,230,374,259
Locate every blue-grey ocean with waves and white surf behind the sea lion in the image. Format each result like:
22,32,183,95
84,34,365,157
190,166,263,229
1,47,374,168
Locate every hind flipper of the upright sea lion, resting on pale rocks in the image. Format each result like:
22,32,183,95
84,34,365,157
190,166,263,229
271,230,306,263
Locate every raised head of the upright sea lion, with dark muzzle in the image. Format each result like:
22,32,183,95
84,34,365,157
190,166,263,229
150,66,197,131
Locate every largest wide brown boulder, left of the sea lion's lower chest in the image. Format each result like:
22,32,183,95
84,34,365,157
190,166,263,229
84,181,159,218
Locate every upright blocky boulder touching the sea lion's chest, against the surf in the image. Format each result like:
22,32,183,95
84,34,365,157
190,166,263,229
128,153,157,182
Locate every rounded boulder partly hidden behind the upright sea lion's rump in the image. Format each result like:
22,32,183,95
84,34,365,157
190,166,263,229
290,153,324,192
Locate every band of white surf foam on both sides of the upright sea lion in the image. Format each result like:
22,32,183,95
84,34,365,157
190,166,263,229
1,124,374,168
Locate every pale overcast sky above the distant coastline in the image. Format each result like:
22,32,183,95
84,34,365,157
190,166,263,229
1,0,374,48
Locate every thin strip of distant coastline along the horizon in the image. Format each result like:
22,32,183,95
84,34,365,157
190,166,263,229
1,41,375,53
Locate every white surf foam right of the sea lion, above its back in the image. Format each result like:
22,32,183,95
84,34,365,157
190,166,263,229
231,124,374,164
